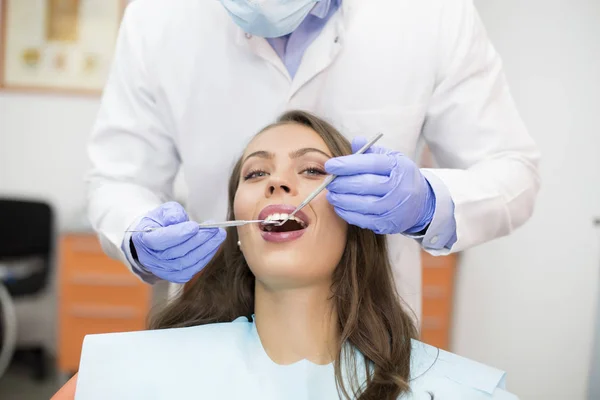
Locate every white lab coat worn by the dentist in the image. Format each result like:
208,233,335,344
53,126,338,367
89,0,539,315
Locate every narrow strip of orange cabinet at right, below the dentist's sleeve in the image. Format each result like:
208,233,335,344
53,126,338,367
421,252,458,350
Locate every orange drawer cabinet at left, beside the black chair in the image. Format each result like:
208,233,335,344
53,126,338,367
58,234,152,374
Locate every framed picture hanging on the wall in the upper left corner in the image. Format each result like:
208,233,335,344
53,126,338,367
0,0,127,94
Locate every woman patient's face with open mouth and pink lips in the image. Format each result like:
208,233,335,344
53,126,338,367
234,124,347,289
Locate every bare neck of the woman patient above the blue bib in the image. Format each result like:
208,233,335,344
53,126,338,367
254,280,339,365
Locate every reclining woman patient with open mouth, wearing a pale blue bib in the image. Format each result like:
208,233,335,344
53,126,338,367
51,111,516,400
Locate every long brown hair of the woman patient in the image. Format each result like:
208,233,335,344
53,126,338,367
150,111,417,400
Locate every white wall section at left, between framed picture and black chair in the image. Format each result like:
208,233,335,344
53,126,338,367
0,92,99,228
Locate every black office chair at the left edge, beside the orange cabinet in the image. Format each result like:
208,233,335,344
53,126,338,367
0,199,54,380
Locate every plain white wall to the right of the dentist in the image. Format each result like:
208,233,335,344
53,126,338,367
453,0,600,400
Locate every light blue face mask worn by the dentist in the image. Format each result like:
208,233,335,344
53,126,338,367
220,0,321,38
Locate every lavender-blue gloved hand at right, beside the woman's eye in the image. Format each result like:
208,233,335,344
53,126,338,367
325,137,435,234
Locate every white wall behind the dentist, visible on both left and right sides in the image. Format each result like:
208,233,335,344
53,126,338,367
0,0,600,400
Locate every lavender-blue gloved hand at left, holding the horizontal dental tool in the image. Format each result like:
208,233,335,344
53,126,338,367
131,202,226,283
